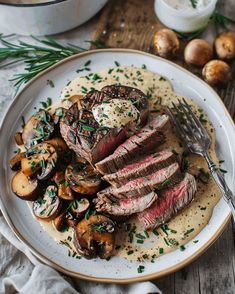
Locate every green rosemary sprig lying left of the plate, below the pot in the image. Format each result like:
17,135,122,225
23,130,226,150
0,34,105,90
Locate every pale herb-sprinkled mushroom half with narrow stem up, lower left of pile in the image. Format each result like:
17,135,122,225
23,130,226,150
33,185,62,221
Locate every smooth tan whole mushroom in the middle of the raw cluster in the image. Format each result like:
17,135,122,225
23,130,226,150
184,39,213,67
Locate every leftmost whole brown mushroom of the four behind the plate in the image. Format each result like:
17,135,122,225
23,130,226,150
153,29,180,58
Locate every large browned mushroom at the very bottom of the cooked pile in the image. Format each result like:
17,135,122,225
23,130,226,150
74,215,115,259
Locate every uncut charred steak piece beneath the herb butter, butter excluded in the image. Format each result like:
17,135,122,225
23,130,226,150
60,85,149,164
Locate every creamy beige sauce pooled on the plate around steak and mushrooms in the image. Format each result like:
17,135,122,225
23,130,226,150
34,67,220,262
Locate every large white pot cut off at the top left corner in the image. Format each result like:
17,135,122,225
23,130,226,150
0,0,108,36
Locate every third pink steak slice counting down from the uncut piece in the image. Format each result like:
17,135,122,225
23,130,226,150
97,163,182,198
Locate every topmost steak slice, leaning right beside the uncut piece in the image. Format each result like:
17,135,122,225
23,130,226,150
96,115,169,174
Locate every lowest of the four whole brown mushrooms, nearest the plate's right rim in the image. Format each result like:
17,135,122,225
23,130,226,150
202,60,232,86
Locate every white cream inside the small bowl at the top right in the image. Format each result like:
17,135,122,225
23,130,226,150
164,0,211,11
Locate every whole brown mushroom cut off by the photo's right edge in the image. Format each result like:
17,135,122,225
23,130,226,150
215,32,235,60
